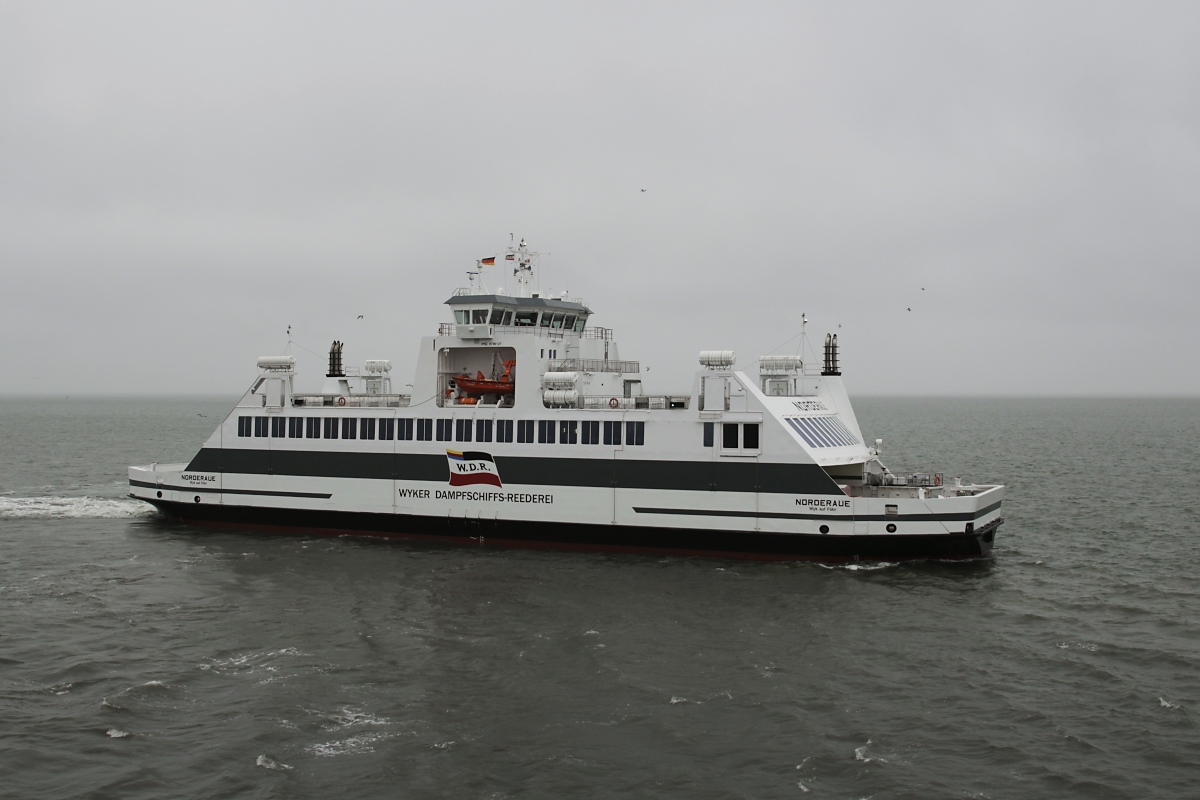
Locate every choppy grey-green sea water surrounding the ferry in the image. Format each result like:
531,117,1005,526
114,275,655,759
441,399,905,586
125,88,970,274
0,398,1200,799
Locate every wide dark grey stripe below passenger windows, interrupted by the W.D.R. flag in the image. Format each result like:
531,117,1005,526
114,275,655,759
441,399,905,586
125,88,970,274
187,447,842,495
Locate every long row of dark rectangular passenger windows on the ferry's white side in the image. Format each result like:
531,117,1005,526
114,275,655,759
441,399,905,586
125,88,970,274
238,416,646,446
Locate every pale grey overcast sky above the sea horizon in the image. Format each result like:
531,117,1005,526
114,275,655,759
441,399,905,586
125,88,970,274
0,0,1200,396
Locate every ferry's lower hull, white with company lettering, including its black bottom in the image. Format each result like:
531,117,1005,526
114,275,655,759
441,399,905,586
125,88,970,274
130,453,1003,561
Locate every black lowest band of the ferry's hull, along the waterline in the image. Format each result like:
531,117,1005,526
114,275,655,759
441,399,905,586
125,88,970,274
131,500,995,561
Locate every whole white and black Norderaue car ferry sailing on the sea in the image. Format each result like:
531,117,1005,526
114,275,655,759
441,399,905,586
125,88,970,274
128,240,1004,563
